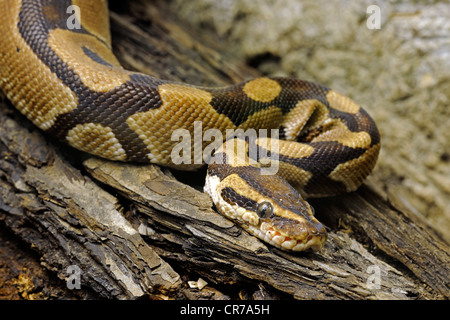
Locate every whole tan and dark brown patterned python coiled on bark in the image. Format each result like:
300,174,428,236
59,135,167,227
0,0,380,251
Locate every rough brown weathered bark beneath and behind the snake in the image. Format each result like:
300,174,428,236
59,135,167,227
0,1,450,299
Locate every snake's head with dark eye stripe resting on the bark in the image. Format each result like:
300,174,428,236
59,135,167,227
205,165,327,251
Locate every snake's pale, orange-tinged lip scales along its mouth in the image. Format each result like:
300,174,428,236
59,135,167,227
255,222,327,252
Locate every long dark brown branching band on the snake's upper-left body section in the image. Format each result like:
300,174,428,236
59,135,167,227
18,0,167,162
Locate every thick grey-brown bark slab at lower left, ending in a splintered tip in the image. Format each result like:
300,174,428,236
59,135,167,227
0,109,180,298
